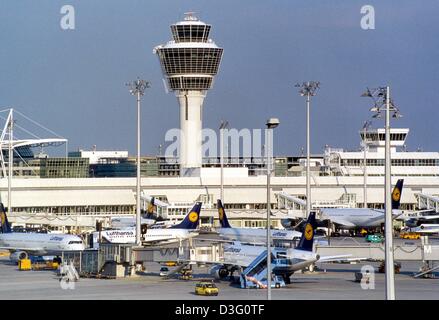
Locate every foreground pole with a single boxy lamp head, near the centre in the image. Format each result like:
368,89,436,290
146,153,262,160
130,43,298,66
265,118,279,300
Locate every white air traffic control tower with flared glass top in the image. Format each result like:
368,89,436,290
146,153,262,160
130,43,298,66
154,13,223,176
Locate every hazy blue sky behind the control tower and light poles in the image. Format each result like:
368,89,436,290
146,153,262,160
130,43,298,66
0,0,439,155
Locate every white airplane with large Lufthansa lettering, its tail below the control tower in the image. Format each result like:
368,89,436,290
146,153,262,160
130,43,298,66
93,202,202,248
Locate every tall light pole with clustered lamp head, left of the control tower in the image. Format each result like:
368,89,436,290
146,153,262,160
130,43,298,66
127,78,150,245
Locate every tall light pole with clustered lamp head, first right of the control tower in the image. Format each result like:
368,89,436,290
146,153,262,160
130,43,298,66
296,81,320,217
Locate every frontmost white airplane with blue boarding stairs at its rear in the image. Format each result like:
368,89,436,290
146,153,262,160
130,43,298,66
189,212,358,283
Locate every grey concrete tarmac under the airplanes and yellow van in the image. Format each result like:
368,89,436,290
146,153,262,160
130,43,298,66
0,257,439,300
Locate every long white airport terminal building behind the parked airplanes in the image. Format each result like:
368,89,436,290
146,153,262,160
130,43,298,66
5,125,439,230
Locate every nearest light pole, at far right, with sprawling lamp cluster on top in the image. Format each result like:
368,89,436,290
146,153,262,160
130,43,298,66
362,86,401,300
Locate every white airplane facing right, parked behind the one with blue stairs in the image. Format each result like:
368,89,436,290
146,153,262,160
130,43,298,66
217,199,302,243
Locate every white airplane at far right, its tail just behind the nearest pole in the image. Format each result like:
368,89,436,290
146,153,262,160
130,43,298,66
321,179,404,229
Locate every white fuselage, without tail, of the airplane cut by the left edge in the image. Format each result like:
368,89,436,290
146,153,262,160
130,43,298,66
0,232,85,255
